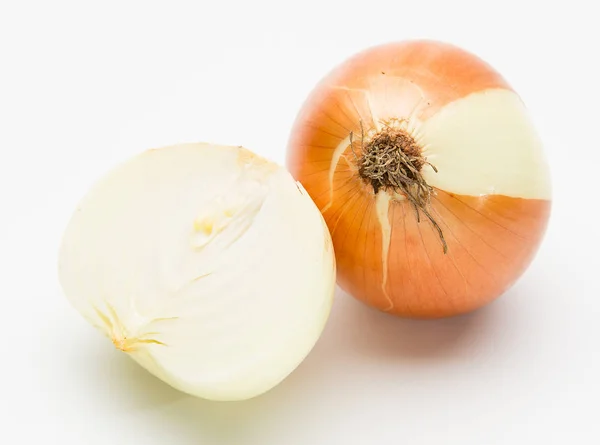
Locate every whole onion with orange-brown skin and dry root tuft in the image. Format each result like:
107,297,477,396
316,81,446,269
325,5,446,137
287,41,551,318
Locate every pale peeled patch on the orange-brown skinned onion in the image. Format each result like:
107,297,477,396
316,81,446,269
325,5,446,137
419,89,551,199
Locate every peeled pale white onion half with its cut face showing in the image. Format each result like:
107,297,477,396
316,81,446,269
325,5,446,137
59,144,335,400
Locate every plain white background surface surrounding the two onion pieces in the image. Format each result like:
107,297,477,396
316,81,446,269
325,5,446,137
0,0,600,445
